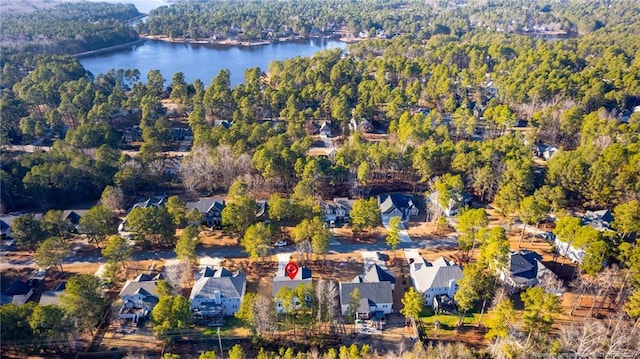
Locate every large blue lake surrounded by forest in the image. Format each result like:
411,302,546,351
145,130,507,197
78,38,347,87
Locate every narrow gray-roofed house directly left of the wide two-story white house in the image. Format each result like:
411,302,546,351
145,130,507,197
118,274,162,323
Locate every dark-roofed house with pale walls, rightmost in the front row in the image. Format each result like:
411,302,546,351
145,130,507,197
500,250,555,293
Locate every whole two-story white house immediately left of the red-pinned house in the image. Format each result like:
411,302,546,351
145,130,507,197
189,267,247,318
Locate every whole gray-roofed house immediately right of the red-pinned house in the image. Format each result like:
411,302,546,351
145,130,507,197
339,264,396,320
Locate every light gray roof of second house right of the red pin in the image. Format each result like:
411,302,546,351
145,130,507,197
411,257,463,292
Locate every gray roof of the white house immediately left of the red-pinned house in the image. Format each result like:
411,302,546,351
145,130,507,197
189,268,247,300
